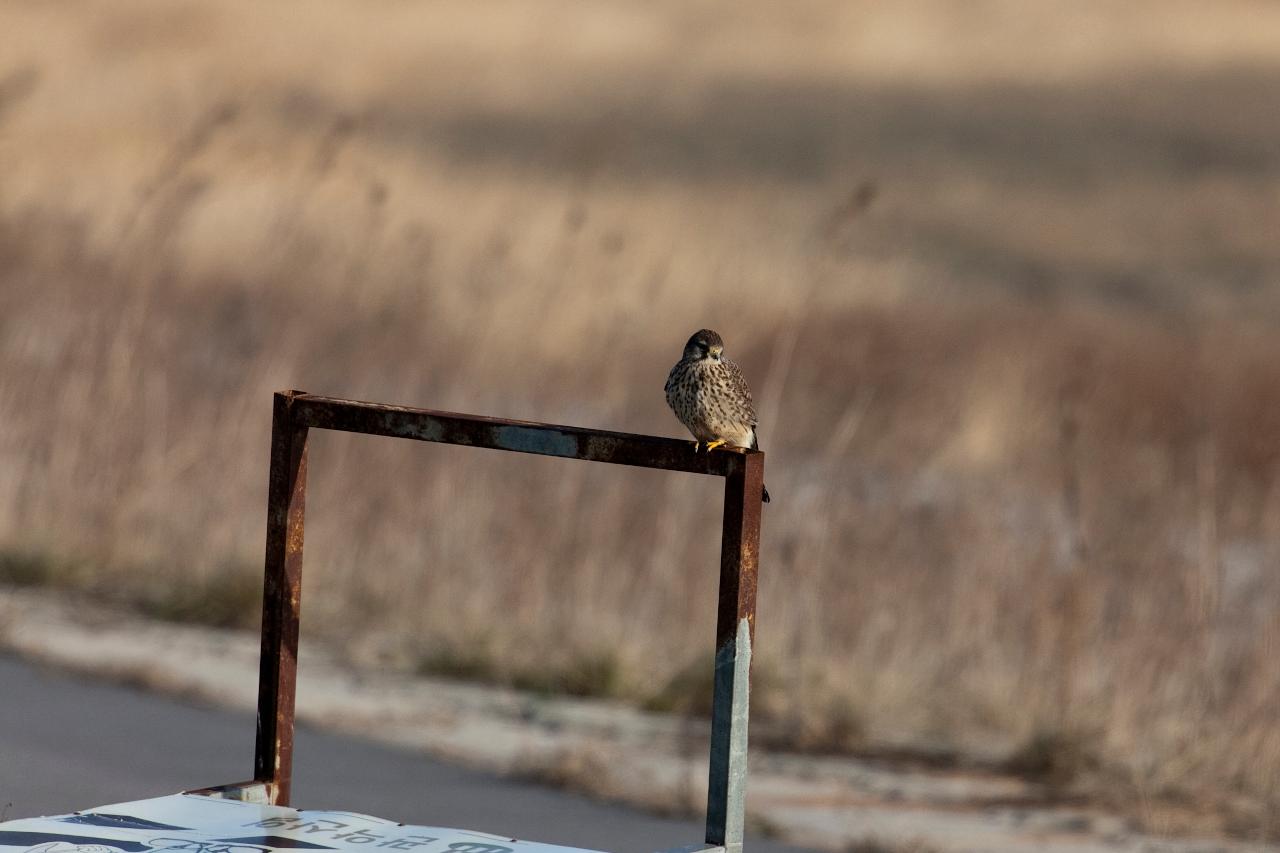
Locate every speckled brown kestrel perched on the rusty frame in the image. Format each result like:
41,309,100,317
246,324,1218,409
667,329,769,503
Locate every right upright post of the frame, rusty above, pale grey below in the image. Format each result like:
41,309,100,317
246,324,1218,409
707,455,764,853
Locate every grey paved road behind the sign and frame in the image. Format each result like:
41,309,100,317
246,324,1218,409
0,657,814,853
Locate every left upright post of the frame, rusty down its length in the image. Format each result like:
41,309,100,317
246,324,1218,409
253,391,307,806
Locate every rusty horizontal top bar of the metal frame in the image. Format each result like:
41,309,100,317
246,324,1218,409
288,391,759,476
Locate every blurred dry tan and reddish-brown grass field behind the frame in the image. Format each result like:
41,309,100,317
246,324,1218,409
0,0,1280,838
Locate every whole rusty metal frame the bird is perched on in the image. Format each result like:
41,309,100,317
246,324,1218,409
247,391,764,853
